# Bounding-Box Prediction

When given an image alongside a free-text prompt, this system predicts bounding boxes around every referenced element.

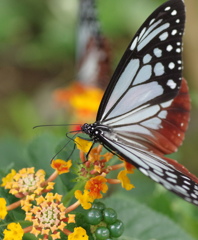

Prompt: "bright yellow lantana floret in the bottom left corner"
[3,223,24,240]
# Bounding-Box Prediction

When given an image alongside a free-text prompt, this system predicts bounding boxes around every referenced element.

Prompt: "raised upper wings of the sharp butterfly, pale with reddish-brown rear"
[97,0,190,154]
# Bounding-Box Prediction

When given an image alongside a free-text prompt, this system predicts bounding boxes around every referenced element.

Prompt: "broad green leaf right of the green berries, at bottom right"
[105,195,193,240]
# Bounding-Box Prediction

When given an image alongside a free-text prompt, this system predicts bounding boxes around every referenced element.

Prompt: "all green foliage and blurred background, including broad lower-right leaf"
[0,0,198,240]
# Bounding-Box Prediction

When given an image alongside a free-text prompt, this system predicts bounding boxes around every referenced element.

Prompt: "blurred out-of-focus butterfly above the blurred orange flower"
[76,0,111,89]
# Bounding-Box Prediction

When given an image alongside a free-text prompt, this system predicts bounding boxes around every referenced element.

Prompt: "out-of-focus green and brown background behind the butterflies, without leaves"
[0,0,198,236]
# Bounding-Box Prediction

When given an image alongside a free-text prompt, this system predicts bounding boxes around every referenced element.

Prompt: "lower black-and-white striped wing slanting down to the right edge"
[98,135,198,205]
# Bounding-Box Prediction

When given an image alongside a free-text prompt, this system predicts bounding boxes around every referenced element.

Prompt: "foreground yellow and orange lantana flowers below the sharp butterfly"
[0,137,134,240]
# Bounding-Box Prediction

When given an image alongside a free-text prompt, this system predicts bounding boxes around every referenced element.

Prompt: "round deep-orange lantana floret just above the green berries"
[85,176,108,199]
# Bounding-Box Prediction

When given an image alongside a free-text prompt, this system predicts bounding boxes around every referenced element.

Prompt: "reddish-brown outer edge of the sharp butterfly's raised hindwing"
[150,78,191,155]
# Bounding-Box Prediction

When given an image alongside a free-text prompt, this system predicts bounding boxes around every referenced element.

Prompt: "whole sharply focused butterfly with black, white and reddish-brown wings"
[81,0,198,205]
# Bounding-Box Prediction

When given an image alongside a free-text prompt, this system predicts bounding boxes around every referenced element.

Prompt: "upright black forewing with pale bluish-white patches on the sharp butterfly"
[97,0,185,121]
